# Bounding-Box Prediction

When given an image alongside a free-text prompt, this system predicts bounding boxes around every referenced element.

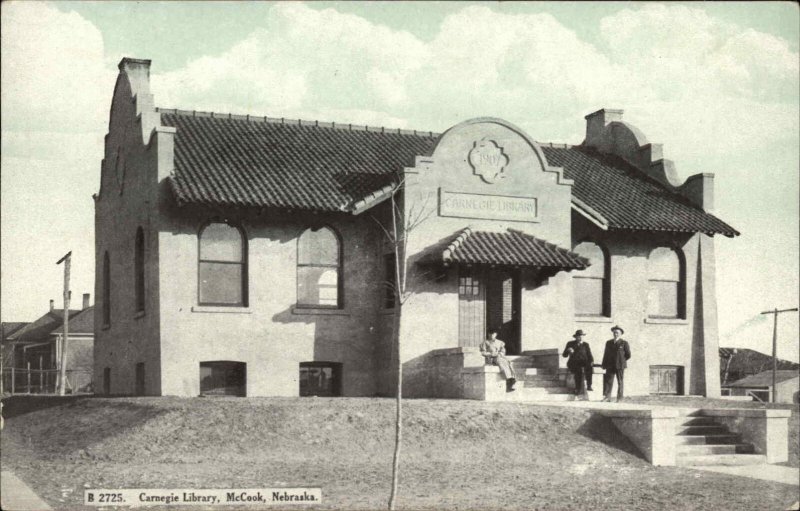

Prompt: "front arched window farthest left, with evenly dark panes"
[198,222,247,307]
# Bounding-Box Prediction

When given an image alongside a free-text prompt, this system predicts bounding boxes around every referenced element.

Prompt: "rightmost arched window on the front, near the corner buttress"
[647,247,686,318]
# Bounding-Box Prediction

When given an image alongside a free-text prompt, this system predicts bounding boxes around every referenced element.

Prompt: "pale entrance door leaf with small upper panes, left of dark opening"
[458,268,486,346]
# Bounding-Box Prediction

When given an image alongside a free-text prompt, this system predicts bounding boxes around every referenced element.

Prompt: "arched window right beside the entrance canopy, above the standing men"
[572,241,611,317]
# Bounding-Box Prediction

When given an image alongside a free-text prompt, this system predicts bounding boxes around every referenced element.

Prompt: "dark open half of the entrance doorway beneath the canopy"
[486,268,521,355]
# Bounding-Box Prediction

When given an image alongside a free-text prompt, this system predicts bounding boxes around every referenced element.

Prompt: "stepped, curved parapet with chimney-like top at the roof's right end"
[582,108,714,211]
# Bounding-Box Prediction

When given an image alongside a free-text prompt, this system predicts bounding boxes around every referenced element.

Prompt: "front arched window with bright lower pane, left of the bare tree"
[297,227,342,307]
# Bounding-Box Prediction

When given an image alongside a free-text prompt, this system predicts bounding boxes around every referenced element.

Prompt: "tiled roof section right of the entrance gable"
[542,146,739,236]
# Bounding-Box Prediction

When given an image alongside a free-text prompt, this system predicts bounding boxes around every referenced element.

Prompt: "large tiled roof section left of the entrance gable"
[160,110,436,212]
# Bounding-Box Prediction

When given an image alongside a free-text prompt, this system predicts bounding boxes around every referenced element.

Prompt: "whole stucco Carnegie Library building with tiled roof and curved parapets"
[94,58,739,397]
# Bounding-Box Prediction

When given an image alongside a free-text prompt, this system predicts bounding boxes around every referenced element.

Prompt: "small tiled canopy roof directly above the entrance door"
[442,228,589,270]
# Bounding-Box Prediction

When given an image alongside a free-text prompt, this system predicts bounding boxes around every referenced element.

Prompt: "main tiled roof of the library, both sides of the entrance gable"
[159,109,739,236]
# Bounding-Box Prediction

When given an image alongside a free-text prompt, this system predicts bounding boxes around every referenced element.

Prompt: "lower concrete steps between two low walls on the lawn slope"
[675,411,767,466]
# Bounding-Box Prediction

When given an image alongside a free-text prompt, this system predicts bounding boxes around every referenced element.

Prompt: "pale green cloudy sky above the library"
[0,1,800,360]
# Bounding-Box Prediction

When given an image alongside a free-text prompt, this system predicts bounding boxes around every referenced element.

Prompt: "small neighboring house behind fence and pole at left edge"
[4,293,94,392]
